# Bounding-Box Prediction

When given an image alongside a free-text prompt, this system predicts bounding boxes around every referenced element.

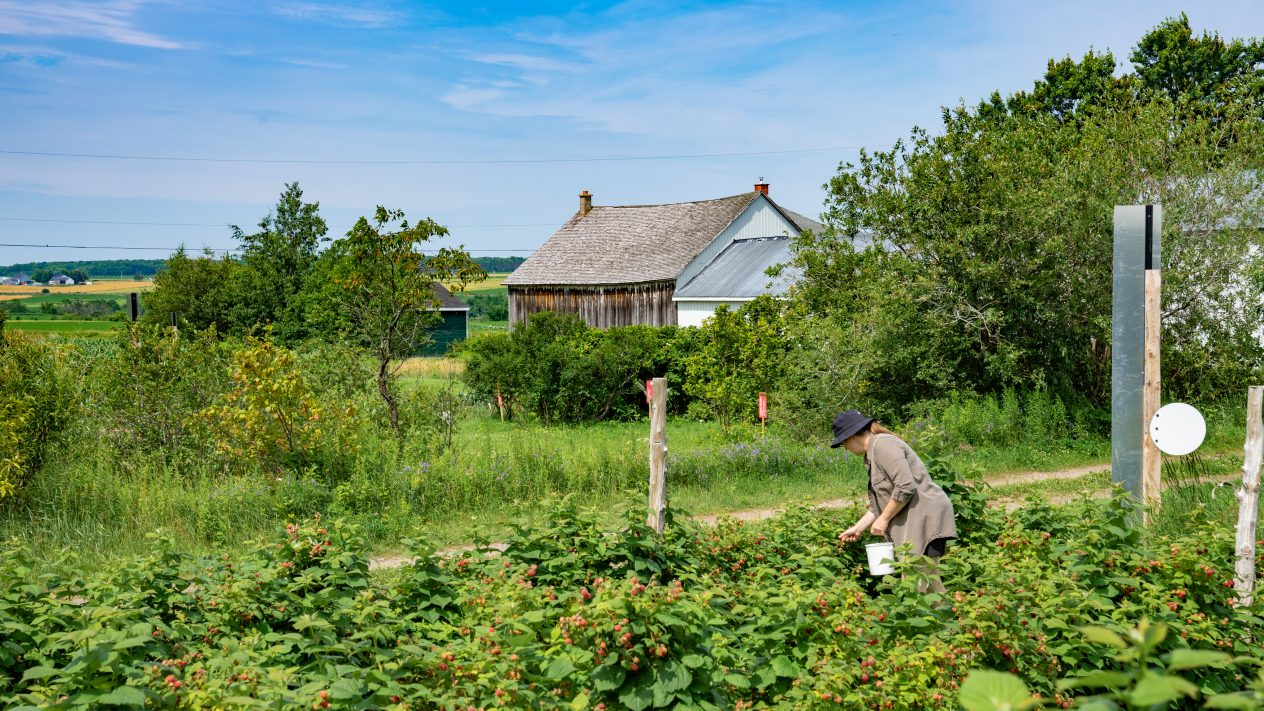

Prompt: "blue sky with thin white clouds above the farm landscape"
[0,0,1264,264]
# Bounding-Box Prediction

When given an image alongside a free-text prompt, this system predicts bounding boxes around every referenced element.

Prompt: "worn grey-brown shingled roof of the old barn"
[504,192,758,286]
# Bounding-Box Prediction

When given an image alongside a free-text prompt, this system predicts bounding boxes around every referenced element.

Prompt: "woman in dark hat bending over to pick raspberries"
[830,410,957,592]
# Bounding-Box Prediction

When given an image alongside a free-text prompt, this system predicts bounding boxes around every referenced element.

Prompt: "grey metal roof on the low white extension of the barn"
[674,237,801,301]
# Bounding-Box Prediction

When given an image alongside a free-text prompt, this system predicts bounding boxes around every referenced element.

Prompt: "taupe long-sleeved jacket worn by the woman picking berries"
[865,434,957,555]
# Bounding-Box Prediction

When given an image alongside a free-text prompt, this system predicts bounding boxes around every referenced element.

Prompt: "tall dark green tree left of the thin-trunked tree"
[233,182,329,343]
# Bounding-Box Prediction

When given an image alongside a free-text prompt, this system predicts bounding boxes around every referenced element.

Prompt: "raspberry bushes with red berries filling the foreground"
[0,485,1261,710]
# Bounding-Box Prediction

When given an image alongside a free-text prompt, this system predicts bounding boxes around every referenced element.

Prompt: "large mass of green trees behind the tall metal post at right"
[782,16,1264,429]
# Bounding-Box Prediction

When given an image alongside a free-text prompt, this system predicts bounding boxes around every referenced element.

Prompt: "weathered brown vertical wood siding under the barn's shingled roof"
[509,281,676,329]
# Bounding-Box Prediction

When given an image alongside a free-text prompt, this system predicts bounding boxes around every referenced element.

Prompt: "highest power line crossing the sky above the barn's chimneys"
[0,145,866,166]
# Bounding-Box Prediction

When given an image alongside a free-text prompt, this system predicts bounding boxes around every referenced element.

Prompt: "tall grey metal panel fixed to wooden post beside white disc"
[1111,205,1163,498]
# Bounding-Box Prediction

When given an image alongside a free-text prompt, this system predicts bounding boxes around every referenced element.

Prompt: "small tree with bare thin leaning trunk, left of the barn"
[330,205,487,435]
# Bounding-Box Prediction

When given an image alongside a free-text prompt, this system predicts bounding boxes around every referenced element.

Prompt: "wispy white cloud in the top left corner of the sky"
[0,0,183,49]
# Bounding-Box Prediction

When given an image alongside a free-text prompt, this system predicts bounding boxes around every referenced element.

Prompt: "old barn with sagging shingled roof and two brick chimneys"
[504,182,822,328]
